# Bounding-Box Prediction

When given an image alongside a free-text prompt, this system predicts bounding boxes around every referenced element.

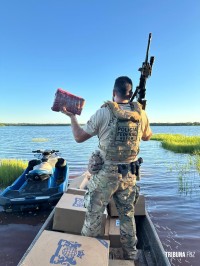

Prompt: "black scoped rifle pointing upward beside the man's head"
[130,33,154,110]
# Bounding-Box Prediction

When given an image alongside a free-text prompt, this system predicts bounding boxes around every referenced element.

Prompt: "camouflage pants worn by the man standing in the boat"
[82,165,139,259]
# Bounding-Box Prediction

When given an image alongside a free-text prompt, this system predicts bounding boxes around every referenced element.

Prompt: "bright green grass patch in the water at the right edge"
[151,134,200,154]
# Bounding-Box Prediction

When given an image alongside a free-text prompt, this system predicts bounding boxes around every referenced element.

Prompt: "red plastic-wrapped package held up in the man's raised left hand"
[51,88,85,115]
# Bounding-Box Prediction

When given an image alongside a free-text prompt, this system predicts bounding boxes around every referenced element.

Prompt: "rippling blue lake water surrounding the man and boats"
[0,126,200,266]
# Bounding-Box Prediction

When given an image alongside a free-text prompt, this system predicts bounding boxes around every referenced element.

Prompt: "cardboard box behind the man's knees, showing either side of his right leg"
[108,195,145,217]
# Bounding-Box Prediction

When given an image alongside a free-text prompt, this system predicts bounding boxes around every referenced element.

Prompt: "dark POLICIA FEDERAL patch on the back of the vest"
[115,121,138,142]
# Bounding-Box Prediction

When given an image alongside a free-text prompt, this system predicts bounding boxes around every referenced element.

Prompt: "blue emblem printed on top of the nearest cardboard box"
[50,239,85,265]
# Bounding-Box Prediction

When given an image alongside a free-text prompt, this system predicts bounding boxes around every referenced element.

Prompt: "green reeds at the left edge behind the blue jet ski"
[0,159,28,188]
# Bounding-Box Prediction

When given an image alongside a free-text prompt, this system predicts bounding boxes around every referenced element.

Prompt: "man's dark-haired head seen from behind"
[113,76,133,101]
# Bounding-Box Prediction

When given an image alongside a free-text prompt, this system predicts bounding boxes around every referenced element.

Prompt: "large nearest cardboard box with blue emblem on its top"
[21,230,109,266]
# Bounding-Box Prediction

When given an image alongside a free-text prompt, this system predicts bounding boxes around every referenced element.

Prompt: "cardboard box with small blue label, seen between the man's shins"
[109,218,122,248]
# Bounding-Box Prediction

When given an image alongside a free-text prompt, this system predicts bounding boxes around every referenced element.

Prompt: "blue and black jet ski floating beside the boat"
[0,150,69,212]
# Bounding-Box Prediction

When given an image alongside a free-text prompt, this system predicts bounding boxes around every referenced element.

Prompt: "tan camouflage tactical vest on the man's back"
[99,101,142,162]
